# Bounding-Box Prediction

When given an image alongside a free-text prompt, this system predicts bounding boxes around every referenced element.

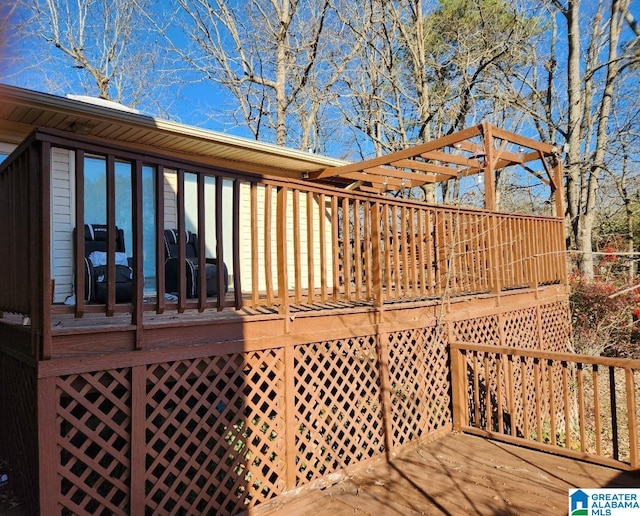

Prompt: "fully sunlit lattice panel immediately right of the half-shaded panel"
[295,336,384,485]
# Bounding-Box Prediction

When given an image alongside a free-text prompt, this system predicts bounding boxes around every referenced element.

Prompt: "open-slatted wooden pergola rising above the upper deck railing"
[303,122,563,215]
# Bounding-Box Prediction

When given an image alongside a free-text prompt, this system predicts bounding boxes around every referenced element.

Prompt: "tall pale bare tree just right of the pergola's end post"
[545,0,637,277]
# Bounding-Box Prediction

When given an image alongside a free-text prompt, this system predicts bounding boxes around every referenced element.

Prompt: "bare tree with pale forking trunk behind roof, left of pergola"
[173,0,360,149]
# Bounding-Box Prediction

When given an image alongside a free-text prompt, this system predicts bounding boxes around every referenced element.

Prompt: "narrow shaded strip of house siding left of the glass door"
[51,148,75,303]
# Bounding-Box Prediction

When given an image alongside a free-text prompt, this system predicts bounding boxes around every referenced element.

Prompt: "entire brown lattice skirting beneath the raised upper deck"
[15,296,566,515]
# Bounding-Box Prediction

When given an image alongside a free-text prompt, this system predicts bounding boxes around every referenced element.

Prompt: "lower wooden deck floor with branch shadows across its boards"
[252,433,640,516]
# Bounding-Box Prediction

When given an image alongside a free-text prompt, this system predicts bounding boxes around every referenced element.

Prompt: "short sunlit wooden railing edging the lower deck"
[450,342,640,469]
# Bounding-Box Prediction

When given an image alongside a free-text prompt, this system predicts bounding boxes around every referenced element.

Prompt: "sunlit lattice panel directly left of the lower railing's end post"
[389,327,451,448]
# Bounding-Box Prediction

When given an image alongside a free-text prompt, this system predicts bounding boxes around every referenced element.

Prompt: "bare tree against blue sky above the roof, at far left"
[8,0,169,113]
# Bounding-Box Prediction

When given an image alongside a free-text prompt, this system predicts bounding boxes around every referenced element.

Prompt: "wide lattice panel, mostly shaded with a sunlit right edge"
[146,350,285,514]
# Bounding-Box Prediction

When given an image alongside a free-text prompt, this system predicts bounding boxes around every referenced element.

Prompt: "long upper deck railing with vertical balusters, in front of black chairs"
[0,131,566,330]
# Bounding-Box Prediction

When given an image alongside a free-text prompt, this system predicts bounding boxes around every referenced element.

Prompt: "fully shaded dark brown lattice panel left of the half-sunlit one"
[56,369,131,514]
